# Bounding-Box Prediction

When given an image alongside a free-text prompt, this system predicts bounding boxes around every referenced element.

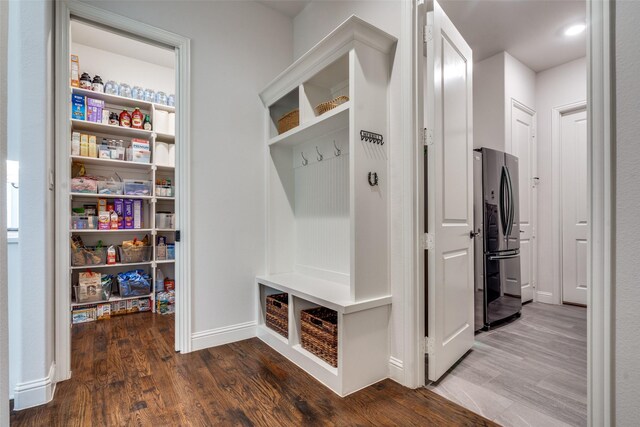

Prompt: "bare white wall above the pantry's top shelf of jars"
[71,42,176,95]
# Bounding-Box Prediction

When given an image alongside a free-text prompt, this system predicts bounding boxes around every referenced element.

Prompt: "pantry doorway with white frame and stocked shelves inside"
[55,2,191,382]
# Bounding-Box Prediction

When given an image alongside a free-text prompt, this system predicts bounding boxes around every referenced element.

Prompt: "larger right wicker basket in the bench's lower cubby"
[300,307,338,368]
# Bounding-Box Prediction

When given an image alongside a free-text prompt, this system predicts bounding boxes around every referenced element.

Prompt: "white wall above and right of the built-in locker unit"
[293,0,411,382]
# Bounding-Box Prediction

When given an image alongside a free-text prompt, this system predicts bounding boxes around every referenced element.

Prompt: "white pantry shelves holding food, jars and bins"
[59,87,176,320]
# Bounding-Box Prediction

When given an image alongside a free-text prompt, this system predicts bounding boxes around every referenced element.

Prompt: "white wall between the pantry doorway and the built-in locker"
[81,1,293,348]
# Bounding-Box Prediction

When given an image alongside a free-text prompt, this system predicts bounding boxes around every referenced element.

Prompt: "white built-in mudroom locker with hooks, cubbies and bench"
[256,16,397,396]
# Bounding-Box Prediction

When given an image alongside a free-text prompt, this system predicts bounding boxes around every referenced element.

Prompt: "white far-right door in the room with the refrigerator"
[560,110,589,305]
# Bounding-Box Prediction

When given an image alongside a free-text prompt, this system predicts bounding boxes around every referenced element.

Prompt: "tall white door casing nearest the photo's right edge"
[587,0,615,427]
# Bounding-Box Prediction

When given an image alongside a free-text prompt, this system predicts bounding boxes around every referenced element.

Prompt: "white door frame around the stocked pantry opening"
[54,1,192,382]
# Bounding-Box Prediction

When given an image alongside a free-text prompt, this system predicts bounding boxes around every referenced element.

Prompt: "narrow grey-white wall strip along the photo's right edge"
[613,1,640,426]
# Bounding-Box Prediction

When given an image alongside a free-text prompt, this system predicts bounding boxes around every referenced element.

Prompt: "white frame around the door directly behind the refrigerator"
[509,98,538,302]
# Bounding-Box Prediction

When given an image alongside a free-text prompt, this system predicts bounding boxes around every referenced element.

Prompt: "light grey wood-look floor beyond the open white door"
[427,303,587,427]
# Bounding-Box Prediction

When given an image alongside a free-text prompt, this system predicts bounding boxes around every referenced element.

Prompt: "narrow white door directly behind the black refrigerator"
[511,101,536,302]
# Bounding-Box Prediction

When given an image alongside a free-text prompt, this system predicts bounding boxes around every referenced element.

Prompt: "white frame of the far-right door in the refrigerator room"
[544,100,587,304]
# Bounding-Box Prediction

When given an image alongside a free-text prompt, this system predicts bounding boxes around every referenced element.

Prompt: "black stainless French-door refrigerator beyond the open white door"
[473,148,522,331]
